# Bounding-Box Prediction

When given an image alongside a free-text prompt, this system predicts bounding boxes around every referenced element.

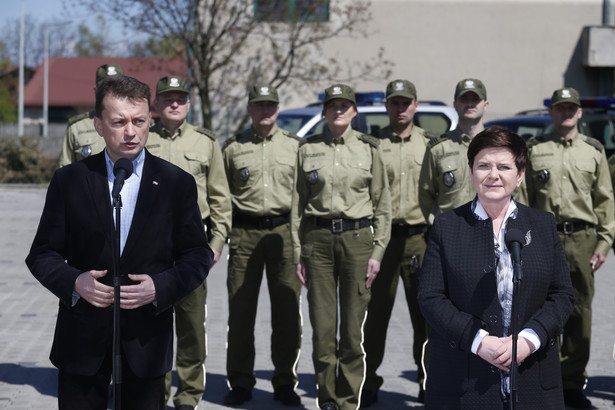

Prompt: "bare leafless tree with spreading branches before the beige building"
[65,0,391,133]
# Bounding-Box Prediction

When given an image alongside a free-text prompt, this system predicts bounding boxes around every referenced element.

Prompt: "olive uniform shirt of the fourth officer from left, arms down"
[291,129,391,264]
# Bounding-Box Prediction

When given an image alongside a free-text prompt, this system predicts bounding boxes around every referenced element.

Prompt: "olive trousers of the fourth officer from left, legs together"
[301,226,373,410]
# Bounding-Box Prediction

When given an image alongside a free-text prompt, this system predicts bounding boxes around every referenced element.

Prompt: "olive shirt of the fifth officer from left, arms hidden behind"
[376,125,435,225]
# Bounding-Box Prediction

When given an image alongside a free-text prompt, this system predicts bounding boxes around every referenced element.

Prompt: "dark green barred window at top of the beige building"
[254,0,329,22]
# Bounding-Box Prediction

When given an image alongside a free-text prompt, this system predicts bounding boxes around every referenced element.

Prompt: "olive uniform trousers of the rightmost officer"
[560,228,598,390]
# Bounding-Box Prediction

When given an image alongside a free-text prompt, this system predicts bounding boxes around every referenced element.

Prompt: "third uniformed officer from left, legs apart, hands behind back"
[223,84,301,406]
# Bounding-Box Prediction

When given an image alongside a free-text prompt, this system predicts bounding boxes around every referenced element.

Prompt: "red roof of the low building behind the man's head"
[24,57,187,107]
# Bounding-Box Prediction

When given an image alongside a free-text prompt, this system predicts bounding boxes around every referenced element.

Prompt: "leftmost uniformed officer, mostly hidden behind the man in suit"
[58,64,124,168]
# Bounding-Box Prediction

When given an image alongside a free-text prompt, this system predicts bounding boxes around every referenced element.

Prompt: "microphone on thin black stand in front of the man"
[112,194,122,410]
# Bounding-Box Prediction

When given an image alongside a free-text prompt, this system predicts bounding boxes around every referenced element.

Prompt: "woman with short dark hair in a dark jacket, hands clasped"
[419,127,574,409]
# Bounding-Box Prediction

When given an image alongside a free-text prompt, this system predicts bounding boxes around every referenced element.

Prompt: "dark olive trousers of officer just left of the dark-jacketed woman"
[364,234,428,393]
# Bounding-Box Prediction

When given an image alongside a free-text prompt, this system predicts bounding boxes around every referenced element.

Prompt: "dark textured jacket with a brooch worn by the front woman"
[419,199,574,409]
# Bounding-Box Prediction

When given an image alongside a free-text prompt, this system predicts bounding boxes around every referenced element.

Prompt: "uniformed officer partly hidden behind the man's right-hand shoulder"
[146,76,231,410]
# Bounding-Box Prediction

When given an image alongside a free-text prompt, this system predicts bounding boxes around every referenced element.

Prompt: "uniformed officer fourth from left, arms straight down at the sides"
[291,84,391,410]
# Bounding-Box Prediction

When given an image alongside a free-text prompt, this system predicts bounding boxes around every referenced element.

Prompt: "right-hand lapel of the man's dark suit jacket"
[120,151,160,259]
